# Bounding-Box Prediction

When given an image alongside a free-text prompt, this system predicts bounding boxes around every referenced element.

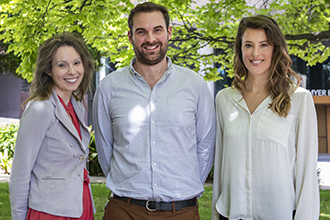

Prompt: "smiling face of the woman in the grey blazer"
[47,46,84,101]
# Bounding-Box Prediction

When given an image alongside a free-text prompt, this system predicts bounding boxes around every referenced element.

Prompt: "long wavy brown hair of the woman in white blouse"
[232,15,300,117]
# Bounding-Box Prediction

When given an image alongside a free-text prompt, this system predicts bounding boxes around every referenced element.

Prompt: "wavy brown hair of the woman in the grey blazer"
[23,32,94,106]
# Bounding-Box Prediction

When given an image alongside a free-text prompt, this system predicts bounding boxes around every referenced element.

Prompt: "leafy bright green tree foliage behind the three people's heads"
[0,0,330,81]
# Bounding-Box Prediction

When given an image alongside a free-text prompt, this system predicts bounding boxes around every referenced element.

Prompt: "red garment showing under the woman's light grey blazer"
[26,96,94,220]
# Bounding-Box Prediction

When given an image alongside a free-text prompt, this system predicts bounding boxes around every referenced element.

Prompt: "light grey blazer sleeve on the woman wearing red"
[9,101,54,220]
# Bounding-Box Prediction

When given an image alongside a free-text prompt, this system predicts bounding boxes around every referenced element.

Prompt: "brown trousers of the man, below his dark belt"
[104,198,200,220]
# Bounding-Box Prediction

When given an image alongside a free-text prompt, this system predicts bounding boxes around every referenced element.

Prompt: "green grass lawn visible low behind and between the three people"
[0,183,330,220]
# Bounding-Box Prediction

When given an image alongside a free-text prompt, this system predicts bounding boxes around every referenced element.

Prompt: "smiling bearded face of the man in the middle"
[128,11,172,65]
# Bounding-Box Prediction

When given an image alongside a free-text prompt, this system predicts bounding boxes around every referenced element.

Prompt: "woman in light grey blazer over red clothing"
[9,33,94,220]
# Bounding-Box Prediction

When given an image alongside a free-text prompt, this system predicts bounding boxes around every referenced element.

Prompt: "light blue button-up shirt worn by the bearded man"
[93,57,215,201]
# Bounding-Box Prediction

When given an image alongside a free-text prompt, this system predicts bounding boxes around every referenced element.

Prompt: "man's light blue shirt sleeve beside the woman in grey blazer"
[93,84,113,176]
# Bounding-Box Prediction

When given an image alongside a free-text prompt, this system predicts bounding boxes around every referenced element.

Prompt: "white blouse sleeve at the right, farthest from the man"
[295,92,320,220]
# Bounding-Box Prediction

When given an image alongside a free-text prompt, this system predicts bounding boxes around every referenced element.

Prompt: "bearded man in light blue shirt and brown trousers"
[93,2,215,220]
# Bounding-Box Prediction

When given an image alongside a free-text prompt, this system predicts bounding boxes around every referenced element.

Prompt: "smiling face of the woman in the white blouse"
[241,28,274,79]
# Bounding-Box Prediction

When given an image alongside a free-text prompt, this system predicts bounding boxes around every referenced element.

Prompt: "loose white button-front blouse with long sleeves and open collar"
[212,87,320,220]
